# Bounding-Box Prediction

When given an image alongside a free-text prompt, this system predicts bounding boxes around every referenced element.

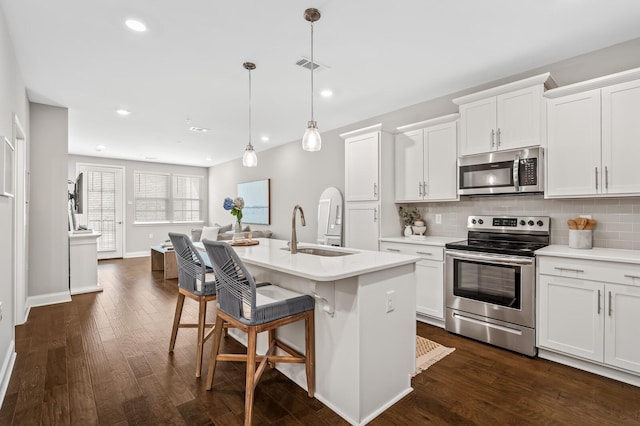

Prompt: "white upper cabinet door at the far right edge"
[602,80,640,194]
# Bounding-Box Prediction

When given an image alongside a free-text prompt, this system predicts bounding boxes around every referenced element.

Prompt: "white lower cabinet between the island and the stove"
[380,241,444,326]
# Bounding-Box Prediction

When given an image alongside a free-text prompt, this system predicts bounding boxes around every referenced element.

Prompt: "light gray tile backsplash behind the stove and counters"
[409,195,640,250]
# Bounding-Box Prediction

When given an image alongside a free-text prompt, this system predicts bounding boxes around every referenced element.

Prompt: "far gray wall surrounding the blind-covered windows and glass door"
[67,155,208,257]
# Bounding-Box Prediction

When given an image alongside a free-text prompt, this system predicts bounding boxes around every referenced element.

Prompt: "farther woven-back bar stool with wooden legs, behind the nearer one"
[169,232,216,377]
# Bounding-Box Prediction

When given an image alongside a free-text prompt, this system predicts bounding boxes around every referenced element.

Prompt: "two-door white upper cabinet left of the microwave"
[395,114,459,202]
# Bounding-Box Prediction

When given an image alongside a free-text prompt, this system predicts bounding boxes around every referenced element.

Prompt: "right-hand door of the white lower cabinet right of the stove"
[604,284,640,373]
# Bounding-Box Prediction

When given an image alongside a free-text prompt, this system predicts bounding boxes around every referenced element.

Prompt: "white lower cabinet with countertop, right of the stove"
[538,256,640,374]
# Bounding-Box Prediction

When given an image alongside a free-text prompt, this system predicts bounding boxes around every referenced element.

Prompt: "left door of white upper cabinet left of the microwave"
[395,129,424,202]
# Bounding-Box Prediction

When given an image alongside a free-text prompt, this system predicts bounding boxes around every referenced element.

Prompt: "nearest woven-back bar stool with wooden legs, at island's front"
[204,241,315,426]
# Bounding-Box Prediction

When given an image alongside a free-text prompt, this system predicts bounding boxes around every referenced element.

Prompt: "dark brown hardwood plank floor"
[0,258,640,425]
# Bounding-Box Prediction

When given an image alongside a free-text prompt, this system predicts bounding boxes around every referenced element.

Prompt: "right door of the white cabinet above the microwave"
[496,85,542,150]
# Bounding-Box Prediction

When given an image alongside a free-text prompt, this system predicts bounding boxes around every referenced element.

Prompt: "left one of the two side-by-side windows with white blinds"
[134,172,170,223]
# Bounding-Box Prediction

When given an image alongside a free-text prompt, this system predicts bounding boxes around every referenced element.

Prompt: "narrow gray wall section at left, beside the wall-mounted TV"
[29,103,69,297]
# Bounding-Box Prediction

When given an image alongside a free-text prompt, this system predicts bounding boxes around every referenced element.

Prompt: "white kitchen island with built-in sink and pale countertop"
[201,239,420,425]
